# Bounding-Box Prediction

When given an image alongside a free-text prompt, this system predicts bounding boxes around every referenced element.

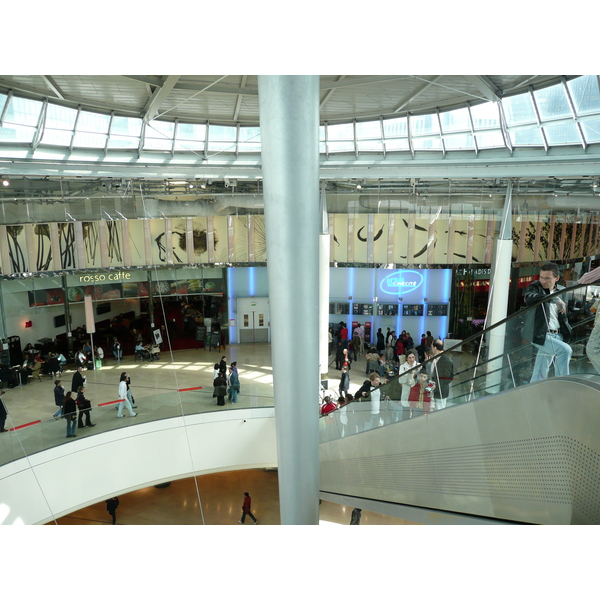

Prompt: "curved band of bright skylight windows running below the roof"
[0,75,600,154]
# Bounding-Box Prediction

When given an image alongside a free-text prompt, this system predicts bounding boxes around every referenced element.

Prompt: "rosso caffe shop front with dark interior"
[0,267,228,364]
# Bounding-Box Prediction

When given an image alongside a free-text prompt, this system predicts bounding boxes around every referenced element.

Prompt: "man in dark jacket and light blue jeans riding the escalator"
[525,262,573,383]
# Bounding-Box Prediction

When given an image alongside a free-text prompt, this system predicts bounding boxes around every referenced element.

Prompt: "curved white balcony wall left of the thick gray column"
[0,407,277,525]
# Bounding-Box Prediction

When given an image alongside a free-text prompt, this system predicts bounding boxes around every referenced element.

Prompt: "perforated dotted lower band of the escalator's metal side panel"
[321,436,600,523]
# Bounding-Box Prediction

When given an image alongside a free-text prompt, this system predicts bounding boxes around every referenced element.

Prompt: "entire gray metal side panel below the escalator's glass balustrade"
[320,376,600,524]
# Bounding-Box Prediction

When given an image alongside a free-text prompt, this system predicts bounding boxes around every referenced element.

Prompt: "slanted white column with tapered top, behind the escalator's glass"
[485,180,513,393]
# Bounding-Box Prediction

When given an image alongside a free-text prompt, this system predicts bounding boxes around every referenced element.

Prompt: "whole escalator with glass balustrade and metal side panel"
[320,278,600,524]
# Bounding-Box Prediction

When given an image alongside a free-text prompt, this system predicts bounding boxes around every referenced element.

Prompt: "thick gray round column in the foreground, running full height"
[258,75,321,525]
